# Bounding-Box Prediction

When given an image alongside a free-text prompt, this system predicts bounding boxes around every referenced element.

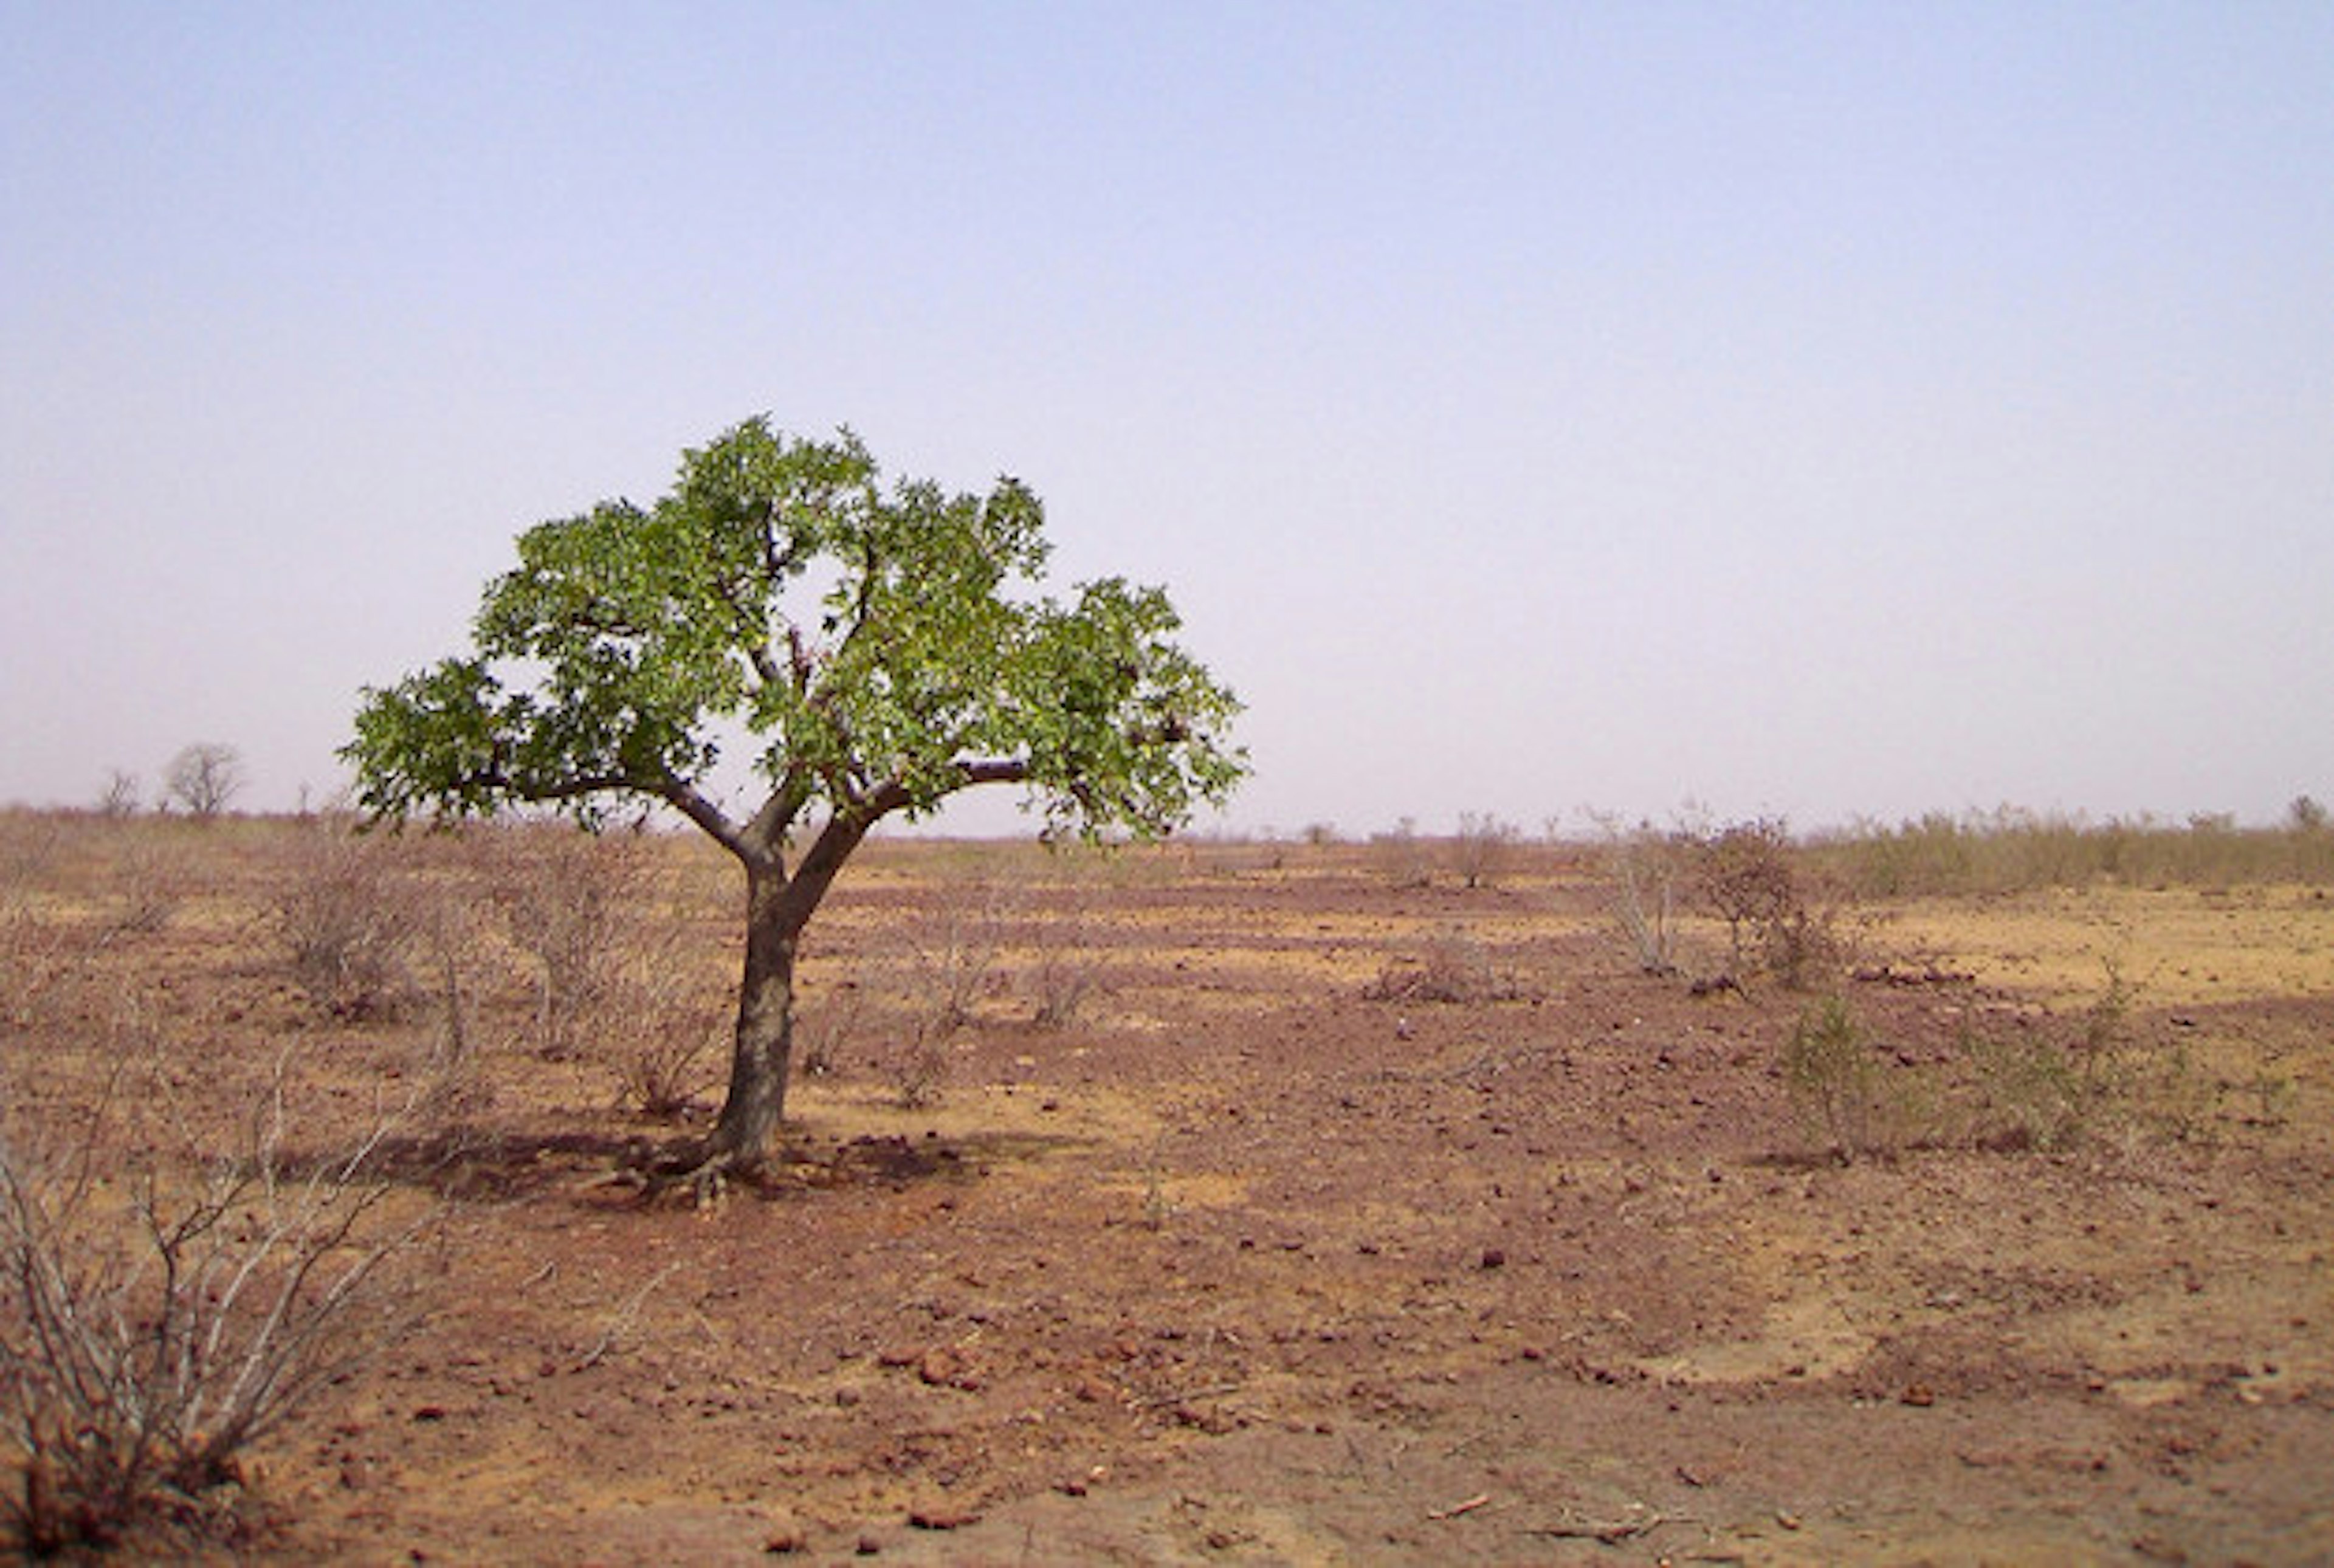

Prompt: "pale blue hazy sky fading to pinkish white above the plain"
[0,0,2334,833]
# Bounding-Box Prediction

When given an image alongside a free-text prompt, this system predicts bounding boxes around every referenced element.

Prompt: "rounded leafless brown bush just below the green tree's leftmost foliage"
[266,819,416,1022]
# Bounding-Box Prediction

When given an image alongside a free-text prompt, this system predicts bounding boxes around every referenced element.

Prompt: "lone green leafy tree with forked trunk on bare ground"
[341,418,1247,1178]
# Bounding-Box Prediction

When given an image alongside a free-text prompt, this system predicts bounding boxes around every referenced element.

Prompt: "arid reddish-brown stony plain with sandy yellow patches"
[0,812,2334,1563]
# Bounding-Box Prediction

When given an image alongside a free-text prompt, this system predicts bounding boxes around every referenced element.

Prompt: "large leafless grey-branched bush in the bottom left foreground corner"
[0,1073,434,1554]
